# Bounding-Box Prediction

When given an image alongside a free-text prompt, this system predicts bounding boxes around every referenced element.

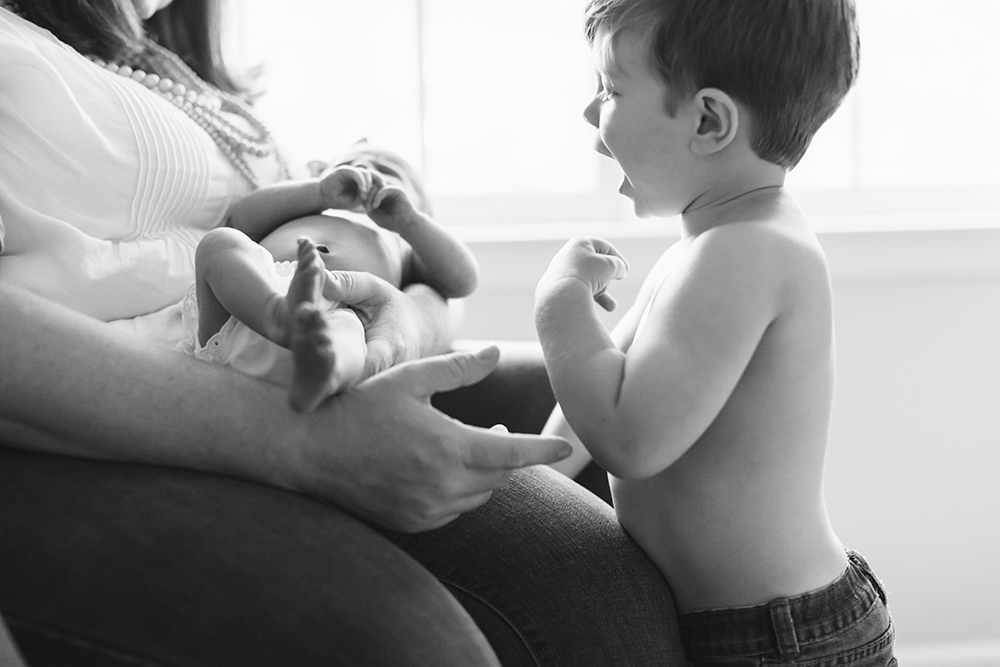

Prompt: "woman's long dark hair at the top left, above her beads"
[19,0,244,93]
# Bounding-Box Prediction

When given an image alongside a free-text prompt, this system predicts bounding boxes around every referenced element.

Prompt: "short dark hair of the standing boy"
[585,0,860,169]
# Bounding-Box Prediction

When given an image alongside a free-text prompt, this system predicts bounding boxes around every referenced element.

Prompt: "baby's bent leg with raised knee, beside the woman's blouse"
[195,227,291,347]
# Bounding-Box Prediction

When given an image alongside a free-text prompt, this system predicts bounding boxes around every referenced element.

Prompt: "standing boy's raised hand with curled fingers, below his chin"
[539,236,628,312]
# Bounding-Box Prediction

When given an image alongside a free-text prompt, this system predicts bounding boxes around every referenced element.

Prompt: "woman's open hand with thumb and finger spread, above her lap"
[292,346,571,532]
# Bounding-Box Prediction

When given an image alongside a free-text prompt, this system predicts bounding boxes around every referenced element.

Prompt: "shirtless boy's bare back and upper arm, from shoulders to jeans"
[612,189,845,611]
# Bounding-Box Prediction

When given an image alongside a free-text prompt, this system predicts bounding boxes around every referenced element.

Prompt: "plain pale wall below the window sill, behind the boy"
[461,218,1000,666]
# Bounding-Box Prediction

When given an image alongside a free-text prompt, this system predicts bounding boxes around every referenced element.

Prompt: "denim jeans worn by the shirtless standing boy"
[678,551,896,667]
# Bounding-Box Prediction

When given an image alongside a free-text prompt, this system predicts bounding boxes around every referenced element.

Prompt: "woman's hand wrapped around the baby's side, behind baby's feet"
[323,271,451,380]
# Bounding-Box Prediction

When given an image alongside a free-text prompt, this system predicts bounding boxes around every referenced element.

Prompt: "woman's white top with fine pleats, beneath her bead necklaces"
[0,8,276,343]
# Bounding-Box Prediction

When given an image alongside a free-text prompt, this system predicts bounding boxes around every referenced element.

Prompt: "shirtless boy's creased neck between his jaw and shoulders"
[681,165,787,237]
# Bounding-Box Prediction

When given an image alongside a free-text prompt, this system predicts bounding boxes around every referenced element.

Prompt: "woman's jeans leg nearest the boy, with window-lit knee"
[386,466,684,667]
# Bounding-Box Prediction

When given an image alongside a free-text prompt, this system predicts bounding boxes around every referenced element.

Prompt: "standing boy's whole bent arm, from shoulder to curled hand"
[535,229,779,479]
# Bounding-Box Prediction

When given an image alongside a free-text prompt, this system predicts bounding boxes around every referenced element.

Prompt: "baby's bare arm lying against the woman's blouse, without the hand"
[226,178,330,242]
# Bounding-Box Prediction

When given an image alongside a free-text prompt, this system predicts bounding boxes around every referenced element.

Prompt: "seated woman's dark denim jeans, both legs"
[0,446,684,667]
